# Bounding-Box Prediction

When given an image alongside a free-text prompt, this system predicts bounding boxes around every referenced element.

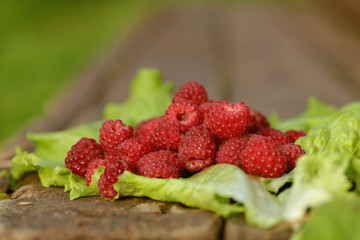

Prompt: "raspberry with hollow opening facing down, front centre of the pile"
[178,125,216,172]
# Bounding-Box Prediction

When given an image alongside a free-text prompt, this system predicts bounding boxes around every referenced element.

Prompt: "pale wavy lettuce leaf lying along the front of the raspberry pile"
[114,164,281,228]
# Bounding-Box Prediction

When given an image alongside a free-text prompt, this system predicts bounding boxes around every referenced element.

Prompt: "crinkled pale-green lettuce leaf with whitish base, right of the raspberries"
[281,104,360,220]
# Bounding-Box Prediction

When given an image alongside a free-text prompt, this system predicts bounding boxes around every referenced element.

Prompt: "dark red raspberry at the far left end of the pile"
[65,137,104,178]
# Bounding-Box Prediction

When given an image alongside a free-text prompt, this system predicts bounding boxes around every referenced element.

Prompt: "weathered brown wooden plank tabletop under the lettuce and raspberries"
[0,5,360,239]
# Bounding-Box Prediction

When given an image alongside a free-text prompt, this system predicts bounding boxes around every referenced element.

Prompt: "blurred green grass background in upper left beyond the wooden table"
[0,0,306,142]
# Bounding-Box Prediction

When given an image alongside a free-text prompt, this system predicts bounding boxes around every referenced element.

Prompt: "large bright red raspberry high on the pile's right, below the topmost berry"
[205,101,250,138]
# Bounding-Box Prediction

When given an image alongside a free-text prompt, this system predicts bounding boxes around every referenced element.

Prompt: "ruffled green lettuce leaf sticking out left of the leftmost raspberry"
[10,122,101,182]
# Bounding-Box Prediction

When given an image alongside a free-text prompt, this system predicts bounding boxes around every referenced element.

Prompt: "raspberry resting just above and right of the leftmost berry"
[100,120,134,152]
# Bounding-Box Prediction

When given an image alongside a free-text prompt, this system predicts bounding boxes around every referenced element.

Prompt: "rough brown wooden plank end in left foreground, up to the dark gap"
[0,175,222,240]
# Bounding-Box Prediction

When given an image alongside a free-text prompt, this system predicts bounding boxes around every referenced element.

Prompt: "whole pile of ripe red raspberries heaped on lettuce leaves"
[65,82,306,199]
